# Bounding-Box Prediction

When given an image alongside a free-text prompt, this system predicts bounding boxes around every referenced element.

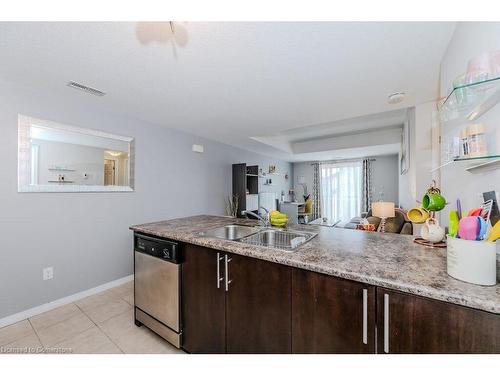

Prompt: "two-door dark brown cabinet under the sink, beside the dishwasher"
[182,245,291,353]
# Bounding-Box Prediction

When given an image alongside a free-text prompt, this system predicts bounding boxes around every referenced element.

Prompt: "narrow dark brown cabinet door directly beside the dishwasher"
[182,245,226,353]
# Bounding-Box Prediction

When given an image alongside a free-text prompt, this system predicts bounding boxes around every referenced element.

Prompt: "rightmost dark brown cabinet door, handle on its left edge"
[377,288,500,353]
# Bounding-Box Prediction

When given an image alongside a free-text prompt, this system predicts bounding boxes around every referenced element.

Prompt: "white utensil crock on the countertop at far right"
[446,236,497,286]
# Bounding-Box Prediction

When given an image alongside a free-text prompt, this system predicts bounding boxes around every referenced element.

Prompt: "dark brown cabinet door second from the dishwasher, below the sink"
[226,254,291,353]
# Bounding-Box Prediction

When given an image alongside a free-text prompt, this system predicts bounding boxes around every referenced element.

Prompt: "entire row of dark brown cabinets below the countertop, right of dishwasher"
[182,245,500,353]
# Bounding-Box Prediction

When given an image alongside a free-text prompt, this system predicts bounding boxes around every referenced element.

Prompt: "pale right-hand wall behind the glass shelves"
[440,22,500,217]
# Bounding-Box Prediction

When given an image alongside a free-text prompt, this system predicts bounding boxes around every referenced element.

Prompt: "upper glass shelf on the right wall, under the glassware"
[439,77,500,122]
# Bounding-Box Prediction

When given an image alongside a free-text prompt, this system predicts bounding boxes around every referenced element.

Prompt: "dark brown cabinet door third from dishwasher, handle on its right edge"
[292,269,375,353]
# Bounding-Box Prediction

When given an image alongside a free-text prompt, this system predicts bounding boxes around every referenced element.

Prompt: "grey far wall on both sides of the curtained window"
[293,155,399,204]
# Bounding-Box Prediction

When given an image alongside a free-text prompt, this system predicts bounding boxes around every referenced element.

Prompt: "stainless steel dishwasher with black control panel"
[134,233,182,348]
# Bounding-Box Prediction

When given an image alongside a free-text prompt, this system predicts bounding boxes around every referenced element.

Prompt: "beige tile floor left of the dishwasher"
[0,282,183,354]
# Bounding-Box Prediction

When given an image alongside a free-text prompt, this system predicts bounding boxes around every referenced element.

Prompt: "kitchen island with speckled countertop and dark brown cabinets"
[131,215,500,353]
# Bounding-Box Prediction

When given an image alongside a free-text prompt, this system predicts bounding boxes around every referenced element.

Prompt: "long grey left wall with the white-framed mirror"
[0,82,291,318]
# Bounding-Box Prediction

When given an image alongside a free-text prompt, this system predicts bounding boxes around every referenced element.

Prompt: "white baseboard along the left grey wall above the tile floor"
[0,275,134,328]
